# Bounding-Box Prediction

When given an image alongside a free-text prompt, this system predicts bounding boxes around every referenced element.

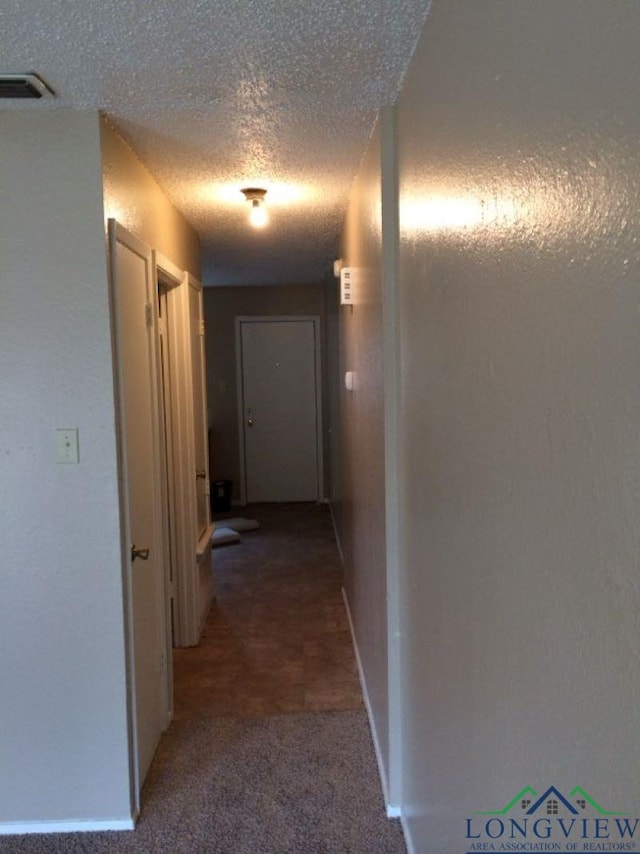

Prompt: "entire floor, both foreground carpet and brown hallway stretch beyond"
[0,504,405,854]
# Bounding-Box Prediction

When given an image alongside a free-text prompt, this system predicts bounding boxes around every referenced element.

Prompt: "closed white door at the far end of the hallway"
[238,318,321,502]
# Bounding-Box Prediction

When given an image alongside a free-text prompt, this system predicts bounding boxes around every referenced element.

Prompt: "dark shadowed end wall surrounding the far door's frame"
[204,285,327,498]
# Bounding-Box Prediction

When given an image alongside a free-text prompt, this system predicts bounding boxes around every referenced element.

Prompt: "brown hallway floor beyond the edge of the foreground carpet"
[174,504,364,720]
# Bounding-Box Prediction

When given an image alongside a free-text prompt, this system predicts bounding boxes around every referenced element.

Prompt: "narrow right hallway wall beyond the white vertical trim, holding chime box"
[334,118,389,796]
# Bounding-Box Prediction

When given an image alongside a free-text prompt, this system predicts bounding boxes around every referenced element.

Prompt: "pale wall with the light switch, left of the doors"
[0,111,130,823]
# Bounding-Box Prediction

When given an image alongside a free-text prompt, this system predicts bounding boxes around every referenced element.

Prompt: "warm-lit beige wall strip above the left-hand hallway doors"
[100,118,200,279]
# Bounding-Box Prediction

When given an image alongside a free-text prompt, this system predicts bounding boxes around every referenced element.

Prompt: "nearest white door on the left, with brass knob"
[109,221,167,795]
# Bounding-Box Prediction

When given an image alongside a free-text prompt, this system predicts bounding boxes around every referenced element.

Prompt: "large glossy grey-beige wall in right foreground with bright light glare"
[399,0,640,854]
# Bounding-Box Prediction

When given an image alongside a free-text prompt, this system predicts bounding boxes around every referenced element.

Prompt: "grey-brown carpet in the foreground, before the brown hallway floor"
[0,711,405,854]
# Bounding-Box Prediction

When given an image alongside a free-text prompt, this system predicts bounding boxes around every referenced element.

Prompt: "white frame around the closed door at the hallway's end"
[236,314,325,506]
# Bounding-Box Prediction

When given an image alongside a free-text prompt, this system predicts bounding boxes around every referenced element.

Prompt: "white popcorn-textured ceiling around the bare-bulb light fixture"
[0,0,429,284]
